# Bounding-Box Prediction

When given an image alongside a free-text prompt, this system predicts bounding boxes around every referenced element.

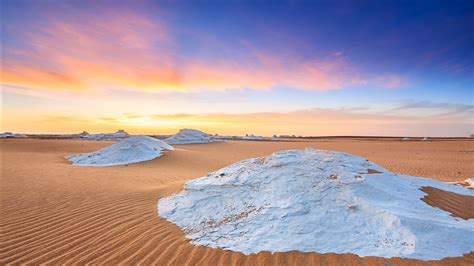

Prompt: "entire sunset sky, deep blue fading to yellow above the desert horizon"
[0,0,474,136]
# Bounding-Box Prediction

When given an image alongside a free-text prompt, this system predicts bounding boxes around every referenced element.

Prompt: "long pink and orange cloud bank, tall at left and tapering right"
[1,4,401,92]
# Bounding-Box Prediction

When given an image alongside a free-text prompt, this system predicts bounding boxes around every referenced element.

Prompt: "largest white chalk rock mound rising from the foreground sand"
[158,149,474,259]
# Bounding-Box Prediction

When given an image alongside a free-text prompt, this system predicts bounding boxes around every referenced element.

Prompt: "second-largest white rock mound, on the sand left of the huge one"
[66,136,174,166]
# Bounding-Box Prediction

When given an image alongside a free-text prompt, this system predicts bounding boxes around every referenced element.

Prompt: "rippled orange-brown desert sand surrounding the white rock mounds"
[0,139,474,265]
